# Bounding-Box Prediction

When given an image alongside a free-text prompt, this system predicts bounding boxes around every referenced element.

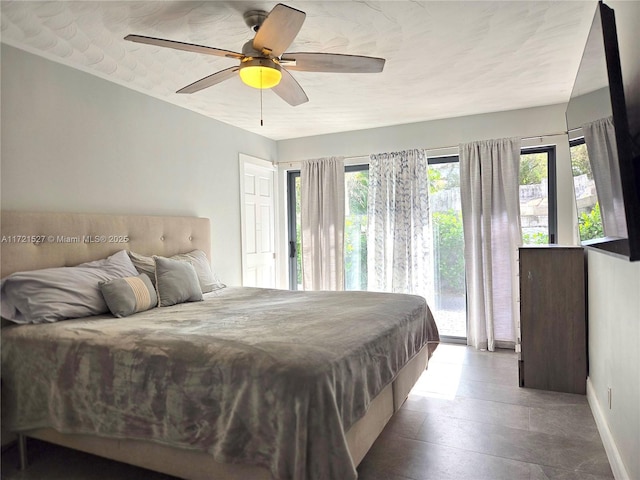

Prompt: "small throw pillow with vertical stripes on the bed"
[100,273,158,317]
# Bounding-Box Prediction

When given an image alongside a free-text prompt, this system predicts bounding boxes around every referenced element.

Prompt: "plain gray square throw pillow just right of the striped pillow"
[153,255,202,307]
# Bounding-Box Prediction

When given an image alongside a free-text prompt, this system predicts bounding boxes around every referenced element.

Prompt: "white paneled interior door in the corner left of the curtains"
[240,154,276,288]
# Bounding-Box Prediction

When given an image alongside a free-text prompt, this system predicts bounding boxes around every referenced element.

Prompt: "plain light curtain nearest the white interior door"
[300,157,345,290]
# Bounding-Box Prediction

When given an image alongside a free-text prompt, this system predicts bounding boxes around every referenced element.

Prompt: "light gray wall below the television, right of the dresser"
[587,251,640,480]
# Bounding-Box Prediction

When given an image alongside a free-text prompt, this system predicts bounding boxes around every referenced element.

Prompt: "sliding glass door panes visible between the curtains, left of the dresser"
[288,157,467,338]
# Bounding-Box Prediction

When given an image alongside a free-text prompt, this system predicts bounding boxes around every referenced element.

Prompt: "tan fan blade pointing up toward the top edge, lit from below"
[253,3,307,57]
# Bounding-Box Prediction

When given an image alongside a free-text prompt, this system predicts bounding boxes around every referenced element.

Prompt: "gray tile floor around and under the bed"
[2,344,613,480]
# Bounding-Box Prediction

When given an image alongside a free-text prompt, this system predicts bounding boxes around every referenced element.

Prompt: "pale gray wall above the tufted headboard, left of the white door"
[1,44,276,285]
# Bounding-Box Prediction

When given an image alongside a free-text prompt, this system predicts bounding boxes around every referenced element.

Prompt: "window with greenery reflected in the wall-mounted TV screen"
[569,138,604,242]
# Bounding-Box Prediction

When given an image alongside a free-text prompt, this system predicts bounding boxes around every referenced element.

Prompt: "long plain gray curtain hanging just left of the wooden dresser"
[460,138,522,351]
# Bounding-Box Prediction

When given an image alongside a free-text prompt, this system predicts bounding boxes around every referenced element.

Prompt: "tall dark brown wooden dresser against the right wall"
[518,245,587,394]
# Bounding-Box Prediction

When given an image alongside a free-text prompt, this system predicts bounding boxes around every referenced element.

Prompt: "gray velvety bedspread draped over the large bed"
[2,287,438,480]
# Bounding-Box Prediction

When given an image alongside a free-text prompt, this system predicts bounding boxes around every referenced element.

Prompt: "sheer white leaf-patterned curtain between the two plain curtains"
[367,150,433,299]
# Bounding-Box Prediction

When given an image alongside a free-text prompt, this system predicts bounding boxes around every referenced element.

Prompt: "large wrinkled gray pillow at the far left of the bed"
[0,250,138,323]
